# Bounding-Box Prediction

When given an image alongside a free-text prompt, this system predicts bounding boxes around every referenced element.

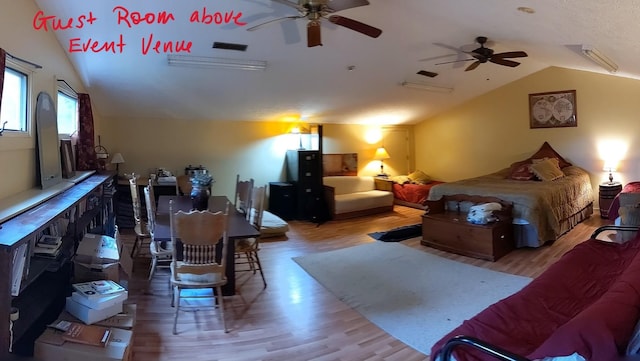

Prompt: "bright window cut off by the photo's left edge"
[0,64,29,132]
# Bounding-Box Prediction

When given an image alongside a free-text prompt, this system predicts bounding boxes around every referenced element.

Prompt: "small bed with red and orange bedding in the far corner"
[389,170,443,209]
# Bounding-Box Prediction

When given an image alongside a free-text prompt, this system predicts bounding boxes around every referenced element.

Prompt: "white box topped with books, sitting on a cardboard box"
[66,280,129,325]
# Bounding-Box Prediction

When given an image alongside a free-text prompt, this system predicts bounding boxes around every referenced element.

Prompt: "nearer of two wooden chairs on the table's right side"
[235,186,267,288]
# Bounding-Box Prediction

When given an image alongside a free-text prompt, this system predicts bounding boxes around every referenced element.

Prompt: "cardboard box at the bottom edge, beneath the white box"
[33,327,133,361]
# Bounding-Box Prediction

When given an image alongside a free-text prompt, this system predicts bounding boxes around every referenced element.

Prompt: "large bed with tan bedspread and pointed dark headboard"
[429,142,594,247]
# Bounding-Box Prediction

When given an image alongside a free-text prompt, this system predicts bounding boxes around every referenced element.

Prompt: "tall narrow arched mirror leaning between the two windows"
[36,92,62,189]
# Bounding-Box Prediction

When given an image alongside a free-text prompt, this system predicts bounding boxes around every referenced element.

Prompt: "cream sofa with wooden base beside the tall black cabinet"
[322,176,393,219]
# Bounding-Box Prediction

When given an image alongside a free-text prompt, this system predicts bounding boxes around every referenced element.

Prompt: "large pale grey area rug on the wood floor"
[293,242,531,355]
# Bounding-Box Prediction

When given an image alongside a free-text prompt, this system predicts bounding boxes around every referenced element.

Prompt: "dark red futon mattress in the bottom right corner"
[431,237,640,361]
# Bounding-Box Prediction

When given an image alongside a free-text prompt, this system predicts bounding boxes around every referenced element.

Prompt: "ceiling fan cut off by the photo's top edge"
[247,0,382,47]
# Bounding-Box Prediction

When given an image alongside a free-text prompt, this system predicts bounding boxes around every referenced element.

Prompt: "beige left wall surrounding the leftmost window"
[0,0,90,199]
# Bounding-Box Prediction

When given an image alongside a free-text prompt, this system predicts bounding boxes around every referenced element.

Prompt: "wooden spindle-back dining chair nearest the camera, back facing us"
[169,200,229,335]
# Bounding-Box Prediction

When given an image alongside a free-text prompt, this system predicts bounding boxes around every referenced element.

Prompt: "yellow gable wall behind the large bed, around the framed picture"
[415,67,640,194]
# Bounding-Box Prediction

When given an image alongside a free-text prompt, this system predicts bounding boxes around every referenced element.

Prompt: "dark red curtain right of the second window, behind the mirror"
[76,93,98,170]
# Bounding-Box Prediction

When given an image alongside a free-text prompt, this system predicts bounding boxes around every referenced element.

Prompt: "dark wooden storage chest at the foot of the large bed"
[421,194,515,261]
